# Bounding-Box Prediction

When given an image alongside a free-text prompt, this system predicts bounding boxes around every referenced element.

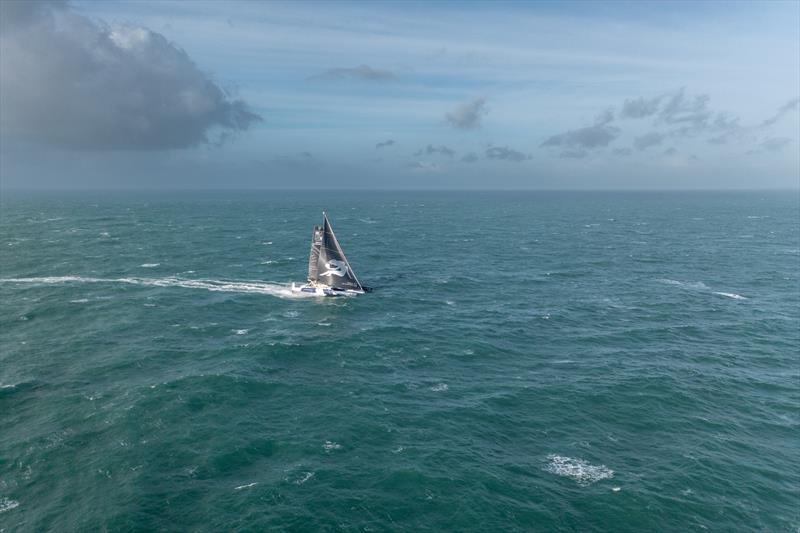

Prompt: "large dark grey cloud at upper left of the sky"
[0,1,262,150]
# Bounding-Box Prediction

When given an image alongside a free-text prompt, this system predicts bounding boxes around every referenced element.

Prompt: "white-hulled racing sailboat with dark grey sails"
[292,211,371,296]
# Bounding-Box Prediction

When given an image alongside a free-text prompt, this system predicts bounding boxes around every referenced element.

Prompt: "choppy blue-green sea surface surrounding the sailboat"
[0,191,800,532]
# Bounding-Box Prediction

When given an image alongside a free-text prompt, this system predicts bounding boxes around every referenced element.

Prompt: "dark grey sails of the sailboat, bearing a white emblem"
[308,212,363,290]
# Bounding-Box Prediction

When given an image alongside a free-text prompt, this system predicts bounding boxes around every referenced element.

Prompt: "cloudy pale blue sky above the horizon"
[0,0,800,190]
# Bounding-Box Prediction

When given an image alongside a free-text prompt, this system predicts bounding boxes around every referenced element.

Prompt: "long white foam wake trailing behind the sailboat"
[0,276,314,298]
